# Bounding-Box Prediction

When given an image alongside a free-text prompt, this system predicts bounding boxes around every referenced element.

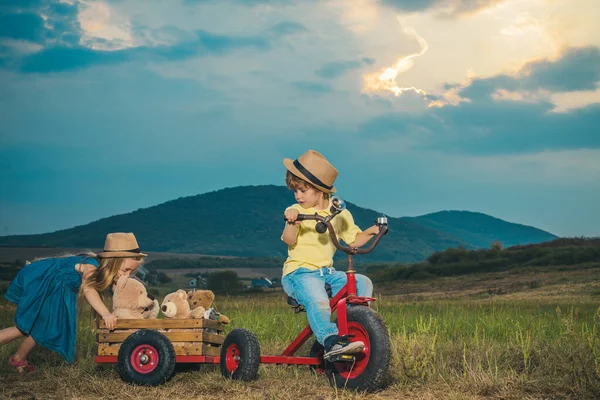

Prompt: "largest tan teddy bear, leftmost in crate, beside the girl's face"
[112,276,159,319]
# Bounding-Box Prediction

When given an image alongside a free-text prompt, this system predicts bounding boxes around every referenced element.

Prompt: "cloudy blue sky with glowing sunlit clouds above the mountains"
[0,0,600,236]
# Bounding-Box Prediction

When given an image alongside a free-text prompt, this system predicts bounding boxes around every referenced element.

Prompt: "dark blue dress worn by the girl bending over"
[4,256,99,363]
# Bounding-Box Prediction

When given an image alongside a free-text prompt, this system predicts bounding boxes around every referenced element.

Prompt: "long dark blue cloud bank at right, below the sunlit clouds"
[360,96,600,155]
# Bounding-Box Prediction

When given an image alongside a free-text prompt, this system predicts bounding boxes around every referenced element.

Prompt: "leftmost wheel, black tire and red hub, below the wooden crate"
[117,329,176,386]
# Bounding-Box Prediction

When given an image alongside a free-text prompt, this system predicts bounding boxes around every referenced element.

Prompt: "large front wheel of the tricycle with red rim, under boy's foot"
[326,306,392,392]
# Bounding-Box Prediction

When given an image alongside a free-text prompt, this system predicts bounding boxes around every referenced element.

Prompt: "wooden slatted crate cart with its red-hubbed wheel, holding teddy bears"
[95,319,225,385]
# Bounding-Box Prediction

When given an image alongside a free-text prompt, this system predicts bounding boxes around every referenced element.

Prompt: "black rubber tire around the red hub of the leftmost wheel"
[117,329,176,386]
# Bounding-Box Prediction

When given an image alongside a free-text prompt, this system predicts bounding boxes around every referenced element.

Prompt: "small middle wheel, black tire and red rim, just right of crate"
[219,328,260,381]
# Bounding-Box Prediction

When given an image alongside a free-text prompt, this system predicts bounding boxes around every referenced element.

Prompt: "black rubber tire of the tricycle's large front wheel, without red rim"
[326,306,392,392]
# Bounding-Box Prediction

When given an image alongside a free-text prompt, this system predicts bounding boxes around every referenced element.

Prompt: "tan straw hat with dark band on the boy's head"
[283,150,338,193]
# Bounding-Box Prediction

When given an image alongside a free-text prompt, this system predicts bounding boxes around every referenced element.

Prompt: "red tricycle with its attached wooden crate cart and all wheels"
[96,197,391,391]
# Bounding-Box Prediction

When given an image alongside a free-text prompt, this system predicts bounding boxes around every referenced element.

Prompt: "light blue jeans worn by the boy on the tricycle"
[281,268,373,344]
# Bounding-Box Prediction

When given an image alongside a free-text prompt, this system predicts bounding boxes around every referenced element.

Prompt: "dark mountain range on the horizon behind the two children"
[0,185,555,261]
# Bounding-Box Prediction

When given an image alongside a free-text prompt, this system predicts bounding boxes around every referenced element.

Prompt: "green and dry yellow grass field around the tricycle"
[0,267,600,399]
